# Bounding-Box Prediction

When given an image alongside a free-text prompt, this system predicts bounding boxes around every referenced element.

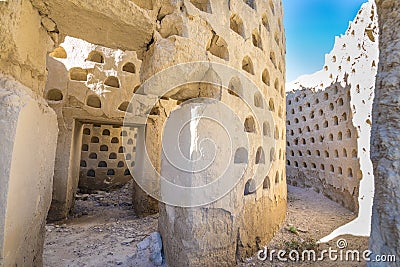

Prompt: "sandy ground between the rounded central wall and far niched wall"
[239,186,368,267]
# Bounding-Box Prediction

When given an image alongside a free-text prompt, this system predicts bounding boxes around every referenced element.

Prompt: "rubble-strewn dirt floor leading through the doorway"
[43,184,158,267]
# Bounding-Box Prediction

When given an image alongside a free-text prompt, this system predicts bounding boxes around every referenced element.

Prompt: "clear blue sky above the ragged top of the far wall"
[283,0,367,82]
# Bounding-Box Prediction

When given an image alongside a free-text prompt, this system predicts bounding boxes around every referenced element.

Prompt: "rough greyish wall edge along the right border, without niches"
[369,0,400,266]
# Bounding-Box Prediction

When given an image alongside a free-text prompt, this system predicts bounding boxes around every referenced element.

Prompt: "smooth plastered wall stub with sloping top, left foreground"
[0,75,57,266]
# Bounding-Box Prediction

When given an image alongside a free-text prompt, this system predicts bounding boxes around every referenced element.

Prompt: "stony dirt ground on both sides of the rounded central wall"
[43,184,368,267]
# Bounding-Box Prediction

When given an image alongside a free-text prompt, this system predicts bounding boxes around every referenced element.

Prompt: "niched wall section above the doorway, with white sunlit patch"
[44,37,145,121]
